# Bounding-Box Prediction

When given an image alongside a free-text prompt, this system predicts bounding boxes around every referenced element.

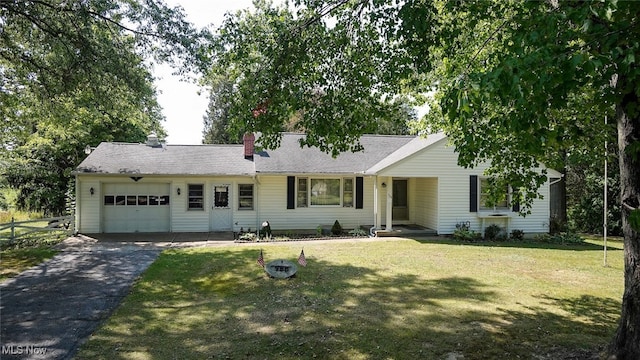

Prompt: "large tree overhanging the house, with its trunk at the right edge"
[212,0,640,359]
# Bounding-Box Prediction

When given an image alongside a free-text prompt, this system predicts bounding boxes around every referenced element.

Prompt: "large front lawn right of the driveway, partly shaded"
[77,239,623,360]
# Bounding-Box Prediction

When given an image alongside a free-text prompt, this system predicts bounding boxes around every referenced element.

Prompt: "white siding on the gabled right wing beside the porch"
[379,140,549,234]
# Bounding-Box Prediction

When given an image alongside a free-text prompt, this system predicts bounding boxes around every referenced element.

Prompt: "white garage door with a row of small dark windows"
[102,183,170,233]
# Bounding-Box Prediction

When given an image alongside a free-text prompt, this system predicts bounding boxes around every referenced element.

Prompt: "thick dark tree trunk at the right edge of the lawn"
[609,88,640,360]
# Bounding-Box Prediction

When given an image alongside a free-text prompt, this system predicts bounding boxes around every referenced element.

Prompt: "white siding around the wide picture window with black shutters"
[258,175,373,230]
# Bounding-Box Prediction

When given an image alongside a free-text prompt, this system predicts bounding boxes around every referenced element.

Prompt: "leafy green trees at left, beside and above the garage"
[0,0,207,214]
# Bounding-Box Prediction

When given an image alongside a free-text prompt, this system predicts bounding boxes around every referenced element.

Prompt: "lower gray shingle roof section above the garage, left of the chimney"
[76,143,255,175]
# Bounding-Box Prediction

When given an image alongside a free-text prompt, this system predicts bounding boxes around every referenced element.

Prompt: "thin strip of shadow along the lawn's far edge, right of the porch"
[411,236,623,251]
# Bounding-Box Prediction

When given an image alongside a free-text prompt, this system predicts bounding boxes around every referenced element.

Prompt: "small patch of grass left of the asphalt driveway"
[0,247,58,283]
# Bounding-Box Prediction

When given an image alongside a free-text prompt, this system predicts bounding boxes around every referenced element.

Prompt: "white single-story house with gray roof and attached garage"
[74,133,561,234]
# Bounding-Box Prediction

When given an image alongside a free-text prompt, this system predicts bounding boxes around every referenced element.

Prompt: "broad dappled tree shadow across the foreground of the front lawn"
[79,249,620,360]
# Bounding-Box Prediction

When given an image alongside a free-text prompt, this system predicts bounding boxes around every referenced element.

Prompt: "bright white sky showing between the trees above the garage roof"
[153,0,253,145]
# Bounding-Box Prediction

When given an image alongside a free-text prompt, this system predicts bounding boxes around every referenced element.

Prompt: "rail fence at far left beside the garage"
[0,215,74,243]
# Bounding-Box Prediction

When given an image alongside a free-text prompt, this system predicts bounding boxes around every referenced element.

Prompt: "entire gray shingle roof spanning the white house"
[76,134,443,175]
